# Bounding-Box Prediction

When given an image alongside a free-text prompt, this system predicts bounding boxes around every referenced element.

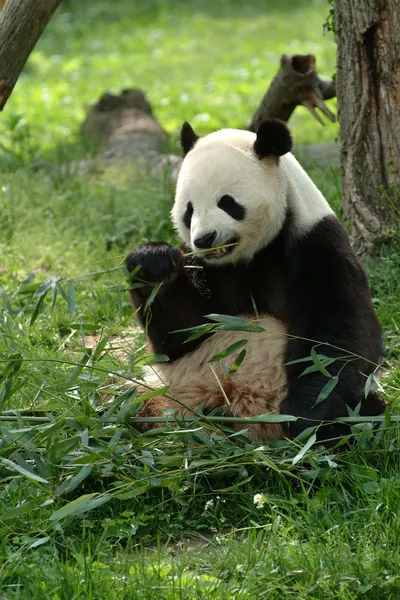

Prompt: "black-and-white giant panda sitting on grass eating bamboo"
[126,119,384,440]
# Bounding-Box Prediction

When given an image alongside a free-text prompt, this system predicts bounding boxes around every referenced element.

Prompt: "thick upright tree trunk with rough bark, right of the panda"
[335,0,400,255]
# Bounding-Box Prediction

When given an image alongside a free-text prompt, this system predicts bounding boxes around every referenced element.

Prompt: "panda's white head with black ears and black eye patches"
[172,119,292,265]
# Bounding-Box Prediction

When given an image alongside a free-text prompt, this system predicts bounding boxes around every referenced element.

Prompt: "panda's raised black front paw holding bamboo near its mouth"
[125,242,183,284]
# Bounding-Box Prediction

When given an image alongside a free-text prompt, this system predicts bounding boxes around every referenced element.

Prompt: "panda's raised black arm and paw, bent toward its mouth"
[125,242,210,360]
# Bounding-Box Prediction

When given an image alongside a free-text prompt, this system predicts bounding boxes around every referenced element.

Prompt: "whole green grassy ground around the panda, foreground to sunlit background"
[0,0,400,600]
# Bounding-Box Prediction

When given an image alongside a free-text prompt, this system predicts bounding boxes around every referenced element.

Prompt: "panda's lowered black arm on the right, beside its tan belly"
[281,216,382,438]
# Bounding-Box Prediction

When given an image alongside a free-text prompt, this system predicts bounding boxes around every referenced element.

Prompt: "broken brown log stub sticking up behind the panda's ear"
[249,54,336,131]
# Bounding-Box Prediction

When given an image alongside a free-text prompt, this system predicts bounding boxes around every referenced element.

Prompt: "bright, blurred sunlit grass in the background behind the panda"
[4,0,338,157]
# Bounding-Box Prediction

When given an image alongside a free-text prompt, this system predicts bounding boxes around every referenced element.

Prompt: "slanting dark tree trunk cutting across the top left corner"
[0,0,61,110]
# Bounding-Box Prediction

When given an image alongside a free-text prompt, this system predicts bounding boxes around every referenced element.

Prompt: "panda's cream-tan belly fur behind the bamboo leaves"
[136,315,287,440]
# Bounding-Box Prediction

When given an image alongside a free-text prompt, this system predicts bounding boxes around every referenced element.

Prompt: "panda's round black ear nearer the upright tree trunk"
[254,119,293,159]
